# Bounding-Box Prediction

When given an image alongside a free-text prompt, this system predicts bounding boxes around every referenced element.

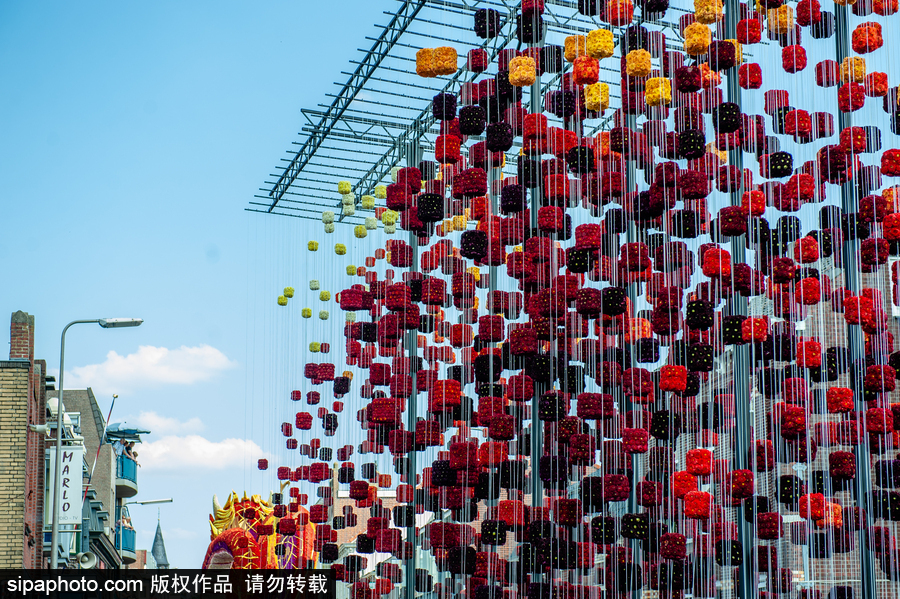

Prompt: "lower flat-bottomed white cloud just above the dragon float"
[136,435,269,472]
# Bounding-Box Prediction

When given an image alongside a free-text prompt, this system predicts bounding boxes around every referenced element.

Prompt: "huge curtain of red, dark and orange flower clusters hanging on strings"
[259,0,900,599]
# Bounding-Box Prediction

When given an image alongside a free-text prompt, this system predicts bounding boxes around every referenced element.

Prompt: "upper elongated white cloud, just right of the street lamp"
[66,345,237,394]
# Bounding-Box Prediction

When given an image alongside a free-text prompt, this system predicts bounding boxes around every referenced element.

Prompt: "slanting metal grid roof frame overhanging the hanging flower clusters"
[246,0,692,225]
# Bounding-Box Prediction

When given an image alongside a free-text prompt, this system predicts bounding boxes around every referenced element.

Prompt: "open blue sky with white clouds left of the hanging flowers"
[0,0,386,568]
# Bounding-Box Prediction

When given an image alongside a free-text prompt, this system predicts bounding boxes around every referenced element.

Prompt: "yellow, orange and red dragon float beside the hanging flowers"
[202,491,317,570]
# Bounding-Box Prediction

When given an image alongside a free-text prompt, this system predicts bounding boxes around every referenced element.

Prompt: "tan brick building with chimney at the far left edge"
[0,311,53,568]
